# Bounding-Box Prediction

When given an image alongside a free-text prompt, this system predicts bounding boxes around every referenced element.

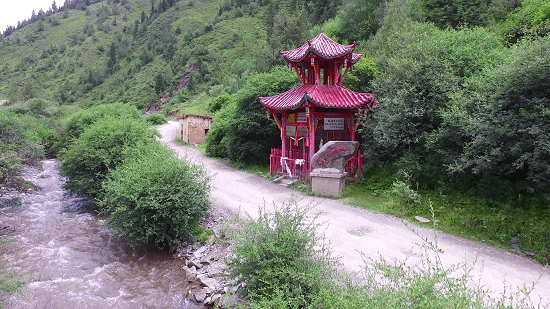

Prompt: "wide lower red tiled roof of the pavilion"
[258,85,378,110]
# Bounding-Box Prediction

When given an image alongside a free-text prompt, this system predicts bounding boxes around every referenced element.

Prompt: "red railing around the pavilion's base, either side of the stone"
[269,148,363,181]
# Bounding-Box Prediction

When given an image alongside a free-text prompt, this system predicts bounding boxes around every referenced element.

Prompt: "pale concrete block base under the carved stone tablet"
[309,168,346,196]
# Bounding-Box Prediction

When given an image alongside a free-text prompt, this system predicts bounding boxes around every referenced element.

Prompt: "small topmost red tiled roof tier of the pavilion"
[279,32,363,64]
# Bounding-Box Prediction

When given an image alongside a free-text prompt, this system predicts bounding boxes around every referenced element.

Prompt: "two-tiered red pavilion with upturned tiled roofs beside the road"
[258,32,378,180]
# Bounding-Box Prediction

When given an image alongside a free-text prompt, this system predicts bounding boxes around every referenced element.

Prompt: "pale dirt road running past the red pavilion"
[157,122,550,302]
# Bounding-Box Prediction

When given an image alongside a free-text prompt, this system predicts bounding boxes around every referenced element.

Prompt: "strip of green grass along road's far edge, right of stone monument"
[340,173,550,264]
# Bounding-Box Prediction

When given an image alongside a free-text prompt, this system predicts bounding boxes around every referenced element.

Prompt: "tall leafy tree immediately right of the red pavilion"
[361,22,503,185]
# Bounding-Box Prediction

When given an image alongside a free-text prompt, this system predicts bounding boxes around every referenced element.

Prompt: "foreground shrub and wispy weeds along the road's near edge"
[223,200,549,309]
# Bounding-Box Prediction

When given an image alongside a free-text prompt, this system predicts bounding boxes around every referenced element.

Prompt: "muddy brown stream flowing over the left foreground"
[0,160,201,309]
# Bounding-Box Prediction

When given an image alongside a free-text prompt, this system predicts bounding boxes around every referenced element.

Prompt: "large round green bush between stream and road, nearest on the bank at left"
[99,142,210,251]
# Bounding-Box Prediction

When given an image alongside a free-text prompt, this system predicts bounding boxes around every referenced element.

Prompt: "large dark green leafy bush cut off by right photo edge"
[446,39,550,187]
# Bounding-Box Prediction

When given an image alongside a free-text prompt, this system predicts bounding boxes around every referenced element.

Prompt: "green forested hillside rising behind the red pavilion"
[0,0,550,260]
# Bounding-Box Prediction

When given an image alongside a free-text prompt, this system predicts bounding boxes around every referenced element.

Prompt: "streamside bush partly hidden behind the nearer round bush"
[60,118,158,198]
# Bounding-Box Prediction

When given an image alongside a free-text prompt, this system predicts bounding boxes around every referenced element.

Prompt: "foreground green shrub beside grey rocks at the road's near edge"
[226,202,335,308]
